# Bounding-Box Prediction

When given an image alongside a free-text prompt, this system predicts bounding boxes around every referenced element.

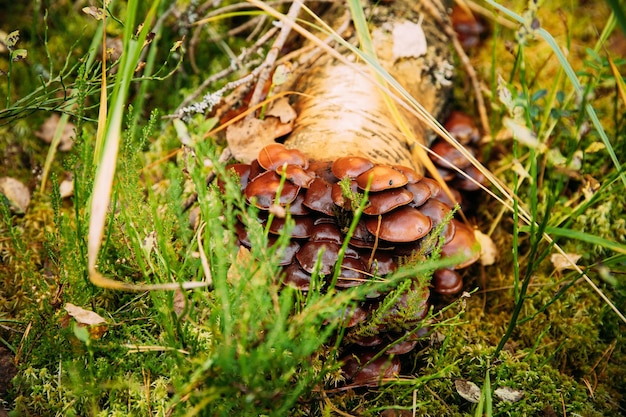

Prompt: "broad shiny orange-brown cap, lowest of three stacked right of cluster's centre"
[365,206,432,242]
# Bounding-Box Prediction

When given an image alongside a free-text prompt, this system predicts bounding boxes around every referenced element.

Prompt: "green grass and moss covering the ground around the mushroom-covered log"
[0,1,626,416]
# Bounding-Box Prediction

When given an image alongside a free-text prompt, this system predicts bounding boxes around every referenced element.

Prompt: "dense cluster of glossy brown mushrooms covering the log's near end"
[222,135,480,386]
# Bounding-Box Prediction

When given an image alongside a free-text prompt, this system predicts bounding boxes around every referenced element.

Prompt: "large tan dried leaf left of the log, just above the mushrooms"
[226,117,292,164]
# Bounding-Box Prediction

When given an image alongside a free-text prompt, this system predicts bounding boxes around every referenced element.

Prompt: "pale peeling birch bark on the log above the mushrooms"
[285,0,452,170]
